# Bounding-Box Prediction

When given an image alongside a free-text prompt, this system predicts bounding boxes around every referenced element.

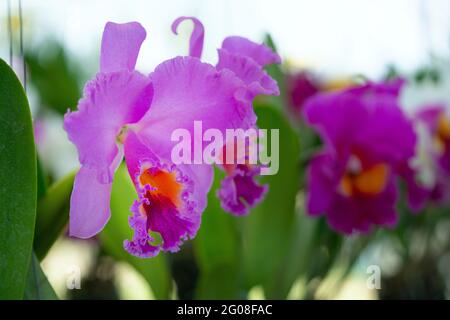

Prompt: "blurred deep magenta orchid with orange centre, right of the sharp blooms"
[304,83,416,234]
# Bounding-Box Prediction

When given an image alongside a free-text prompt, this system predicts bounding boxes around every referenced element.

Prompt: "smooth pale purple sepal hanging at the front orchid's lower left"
[69,167,112,238]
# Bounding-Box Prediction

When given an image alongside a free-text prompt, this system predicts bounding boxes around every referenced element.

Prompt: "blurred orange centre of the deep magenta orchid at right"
[339,157,389,197]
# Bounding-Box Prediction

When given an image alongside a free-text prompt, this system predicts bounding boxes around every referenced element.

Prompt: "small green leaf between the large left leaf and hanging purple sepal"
[34,171,75,261]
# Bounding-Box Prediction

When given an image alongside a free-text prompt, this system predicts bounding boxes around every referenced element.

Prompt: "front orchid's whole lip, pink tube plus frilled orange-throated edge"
[124,131,212,257]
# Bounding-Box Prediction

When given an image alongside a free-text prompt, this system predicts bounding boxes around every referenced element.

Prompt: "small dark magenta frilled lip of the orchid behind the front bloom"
[217,165,268,216]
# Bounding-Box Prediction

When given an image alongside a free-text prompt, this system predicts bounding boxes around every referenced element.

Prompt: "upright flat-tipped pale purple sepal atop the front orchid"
[100,22,146,73]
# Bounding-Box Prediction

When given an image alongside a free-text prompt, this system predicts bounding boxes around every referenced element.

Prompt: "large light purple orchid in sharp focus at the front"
[64,17,276,257]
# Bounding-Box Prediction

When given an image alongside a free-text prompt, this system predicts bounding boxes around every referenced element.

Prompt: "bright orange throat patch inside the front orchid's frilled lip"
[139,169,182,206]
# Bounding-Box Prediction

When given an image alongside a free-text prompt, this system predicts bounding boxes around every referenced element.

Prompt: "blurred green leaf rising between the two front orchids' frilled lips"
[194,169,245,299]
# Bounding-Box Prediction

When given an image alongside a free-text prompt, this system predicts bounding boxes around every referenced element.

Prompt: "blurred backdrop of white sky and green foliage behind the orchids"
[0,0,450,299]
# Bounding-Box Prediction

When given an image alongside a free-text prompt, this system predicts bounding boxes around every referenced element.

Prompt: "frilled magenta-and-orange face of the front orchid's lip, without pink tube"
[124,160,199,257]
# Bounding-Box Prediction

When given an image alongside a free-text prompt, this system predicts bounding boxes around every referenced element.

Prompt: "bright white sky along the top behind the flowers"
[0,0,450,77]
